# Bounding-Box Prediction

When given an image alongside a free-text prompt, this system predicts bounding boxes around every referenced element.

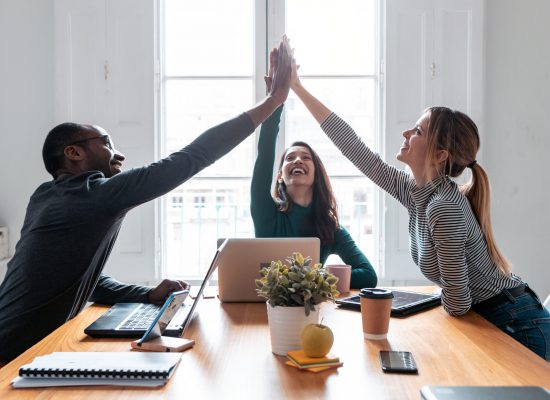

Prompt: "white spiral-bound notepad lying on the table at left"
[12,352,181,388]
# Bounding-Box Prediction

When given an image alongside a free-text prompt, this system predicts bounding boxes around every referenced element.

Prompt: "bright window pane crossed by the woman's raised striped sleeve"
[286,78,376,176]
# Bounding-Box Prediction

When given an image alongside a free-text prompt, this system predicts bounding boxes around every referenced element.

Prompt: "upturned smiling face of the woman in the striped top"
[396,113,430,176]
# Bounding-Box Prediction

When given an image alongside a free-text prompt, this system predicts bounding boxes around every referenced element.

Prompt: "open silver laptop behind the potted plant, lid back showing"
[217,238,321,302]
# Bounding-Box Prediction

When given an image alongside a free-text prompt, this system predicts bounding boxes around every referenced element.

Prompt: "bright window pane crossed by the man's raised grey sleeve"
[165,79,254,176]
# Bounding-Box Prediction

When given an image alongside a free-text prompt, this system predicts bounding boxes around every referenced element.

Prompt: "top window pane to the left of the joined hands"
[164,0,254,76]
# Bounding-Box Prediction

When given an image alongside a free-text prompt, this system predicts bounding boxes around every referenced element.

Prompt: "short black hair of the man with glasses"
[42,122,86,179]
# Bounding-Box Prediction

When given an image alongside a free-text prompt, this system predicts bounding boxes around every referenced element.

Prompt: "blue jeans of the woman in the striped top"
[476,288,550,361]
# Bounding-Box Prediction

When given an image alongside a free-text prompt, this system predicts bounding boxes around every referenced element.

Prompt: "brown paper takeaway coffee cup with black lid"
[359,288,393,340]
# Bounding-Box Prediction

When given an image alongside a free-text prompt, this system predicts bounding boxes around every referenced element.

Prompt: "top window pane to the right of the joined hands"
[286,0,376,75]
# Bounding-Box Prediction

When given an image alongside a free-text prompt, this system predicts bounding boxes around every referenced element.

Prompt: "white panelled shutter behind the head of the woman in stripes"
[381,0,484,285]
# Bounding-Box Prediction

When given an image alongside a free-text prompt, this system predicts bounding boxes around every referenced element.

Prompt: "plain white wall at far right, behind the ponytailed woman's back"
[488,0,550,298]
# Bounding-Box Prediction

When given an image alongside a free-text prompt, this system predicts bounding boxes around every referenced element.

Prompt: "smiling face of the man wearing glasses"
[81,125,125,178]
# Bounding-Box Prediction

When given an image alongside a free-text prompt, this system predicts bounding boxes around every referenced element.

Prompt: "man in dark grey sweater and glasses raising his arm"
[0,38,291,366]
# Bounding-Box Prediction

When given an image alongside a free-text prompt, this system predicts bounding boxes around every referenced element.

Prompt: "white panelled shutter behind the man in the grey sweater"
[53,0,157,284]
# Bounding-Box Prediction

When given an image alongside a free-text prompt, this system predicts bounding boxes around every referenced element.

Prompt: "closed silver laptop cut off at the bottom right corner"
[420,386,550,400]
